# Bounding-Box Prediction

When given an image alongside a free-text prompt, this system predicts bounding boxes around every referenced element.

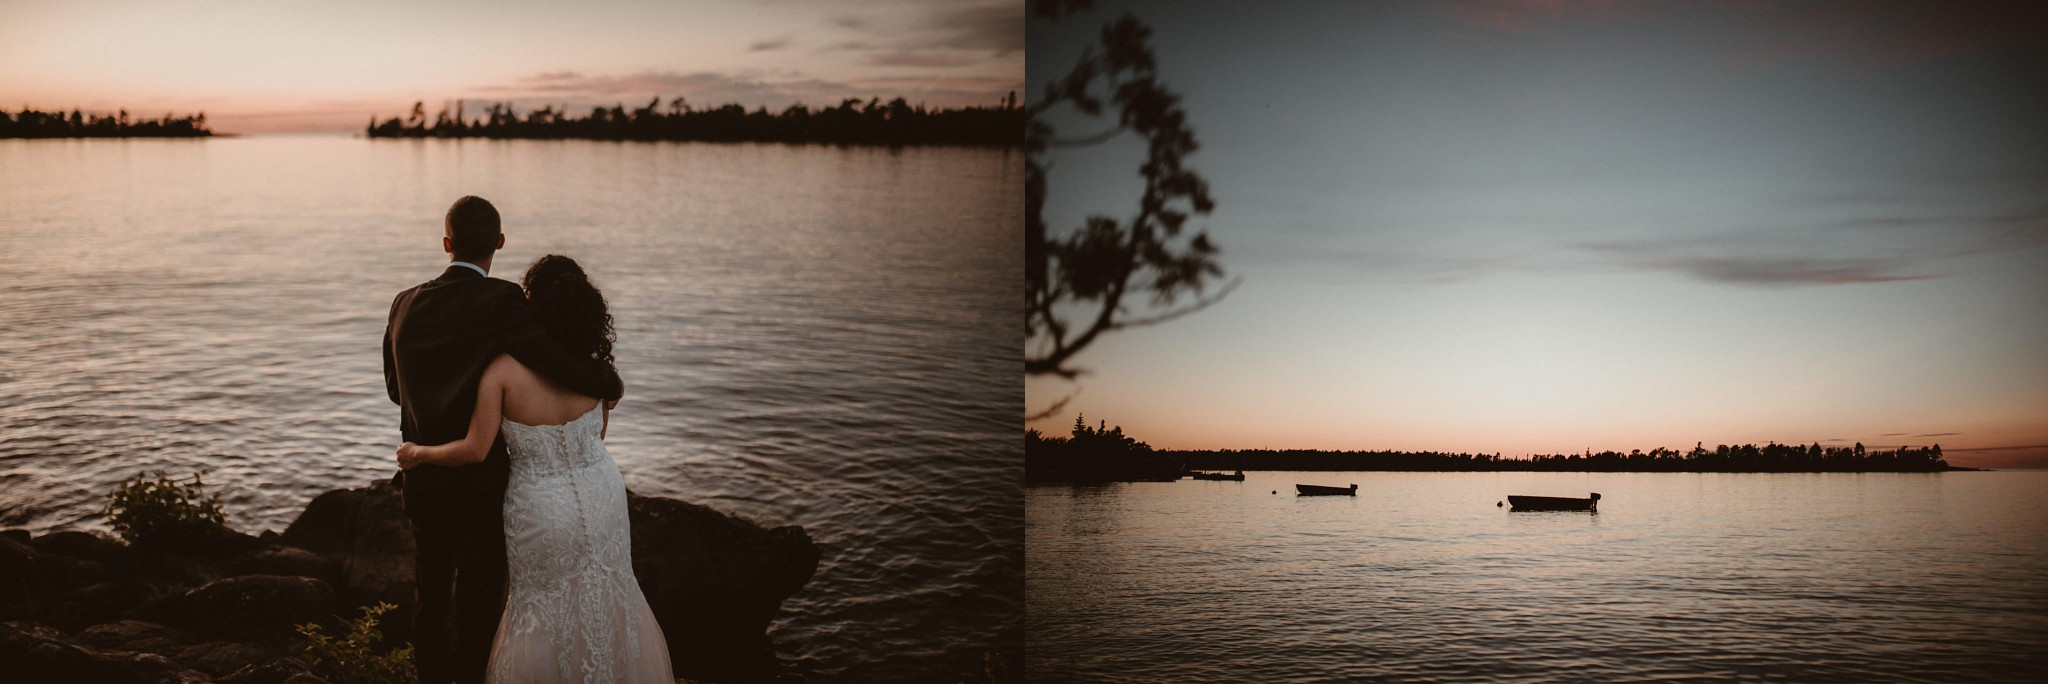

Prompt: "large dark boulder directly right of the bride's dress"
[627,496,817,680]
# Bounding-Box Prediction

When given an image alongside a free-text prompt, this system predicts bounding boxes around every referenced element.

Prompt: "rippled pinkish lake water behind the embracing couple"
[0,137,1024,680]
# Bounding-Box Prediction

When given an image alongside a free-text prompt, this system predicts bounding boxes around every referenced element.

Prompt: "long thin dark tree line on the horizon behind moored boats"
[1171,442,1958,473]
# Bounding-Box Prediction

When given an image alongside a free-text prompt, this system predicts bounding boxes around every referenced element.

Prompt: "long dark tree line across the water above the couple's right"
[367,92,1026,147]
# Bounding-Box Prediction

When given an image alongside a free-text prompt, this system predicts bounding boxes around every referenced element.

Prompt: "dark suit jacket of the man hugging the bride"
[383,264,625,516]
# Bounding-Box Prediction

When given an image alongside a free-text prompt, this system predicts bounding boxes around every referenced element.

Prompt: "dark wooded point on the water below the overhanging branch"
[1024,416,1184,481]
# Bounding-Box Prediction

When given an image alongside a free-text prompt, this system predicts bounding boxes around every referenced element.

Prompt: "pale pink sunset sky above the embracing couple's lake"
[0,0,1024,133]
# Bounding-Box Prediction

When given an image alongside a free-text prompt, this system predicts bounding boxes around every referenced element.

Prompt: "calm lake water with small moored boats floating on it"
[1024,471,2048,682]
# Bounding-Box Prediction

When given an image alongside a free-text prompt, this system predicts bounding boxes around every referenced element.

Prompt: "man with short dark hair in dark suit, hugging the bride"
[383,197,625,684]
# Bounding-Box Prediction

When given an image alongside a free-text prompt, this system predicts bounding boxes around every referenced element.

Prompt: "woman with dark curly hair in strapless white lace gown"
[397,254,674,682]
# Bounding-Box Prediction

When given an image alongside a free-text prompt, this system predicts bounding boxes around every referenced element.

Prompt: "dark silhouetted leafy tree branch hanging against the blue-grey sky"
[1024,0,1235,379]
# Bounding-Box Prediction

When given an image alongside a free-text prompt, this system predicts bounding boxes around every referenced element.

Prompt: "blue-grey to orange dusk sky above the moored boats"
[1026,0,2048,467]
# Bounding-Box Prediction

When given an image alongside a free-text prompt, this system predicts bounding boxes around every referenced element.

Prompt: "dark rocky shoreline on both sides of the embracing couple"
[0,481,819,684]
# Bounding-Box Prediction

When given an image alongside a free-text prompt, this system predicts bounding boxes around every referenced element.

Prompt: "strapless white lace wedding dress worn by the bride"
[487,408,674,682]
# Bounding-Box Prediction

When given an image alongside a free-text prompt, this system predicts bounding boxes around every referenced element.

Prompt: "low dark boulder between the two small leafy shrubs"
[137,575,336,639]
